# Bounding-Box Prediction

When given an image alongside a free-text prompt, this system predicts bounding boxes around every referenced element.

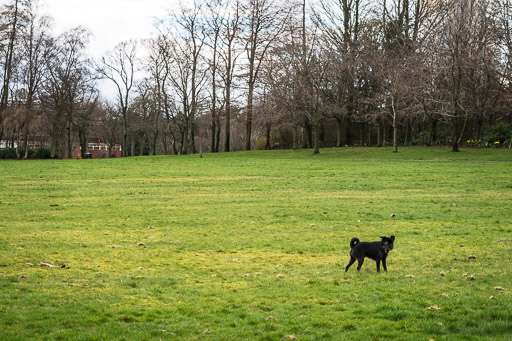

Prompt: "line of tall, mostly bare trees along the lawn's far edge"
[0,0,512,158]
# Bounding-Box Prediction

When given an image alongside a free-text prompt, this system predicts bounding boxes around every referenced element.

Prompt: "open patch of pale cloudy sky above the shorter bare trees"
[40,0,179,58]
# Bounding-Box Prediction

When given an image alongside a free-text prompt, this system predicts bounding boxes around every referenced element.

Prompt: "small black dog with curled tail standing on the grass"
[345,236,395,272]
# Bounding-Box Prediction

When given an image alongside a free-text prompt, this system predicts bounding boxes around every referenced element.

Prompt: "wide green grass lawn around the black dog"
[0,148,512,340]
